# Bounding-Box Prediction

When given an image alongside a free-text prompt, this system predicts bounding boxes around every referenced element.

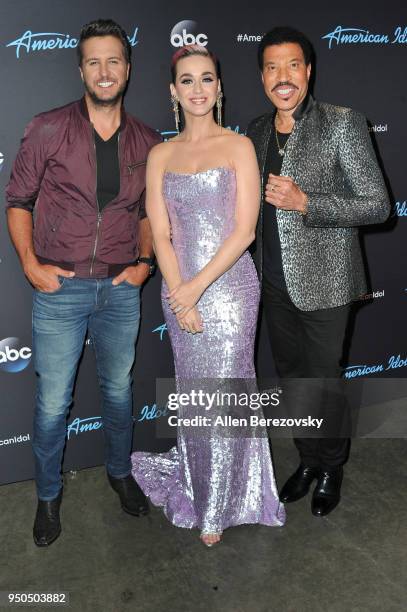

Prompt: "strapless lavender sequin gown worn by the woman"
[132,167,285,533]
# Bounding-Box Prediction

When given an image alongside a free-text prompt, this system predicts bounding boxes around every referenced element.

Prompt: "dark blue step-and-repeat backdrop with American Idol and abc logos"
[0,0,407,484]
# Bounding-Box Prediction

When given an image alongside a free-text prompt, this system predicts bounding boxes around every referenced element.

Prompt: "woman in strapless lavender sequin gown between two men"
[132,46,285,545]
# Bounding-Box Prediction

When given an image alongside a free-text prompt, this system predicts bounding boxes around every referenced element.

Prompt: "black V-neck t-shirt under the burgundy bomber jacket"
[95,128,120,211]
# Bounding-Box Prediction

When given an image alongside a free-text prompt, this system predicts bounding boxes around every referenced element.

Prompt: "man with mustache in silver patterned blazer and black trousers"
[247,27,390,516]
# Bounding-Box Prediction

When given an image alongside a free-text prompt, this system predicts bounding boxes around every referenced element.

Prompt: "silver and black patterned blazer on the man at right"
[247,96,390,310]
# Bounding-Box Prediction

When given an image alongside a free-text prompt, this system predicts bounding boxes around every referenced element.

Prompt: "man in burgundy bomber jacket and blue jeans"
[7,20,160,546]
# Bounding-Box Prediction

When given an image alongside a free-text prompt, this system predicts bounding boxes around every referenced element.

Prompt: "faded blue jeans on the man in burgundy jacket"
[33,277,140,501]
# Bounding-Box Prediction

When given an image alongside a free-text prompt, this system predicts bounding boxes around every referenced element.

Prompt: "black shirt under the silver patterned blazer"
[263,128,290,290]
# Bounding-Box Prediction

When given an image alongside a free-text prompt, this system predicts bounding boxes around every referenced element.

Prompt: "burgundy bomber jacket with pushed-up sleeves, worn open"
[6,98,161,278]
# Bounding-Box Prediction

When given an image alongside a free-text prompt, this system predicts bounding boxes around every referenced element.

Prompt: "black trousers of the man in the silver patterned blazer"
[262,279,350,469]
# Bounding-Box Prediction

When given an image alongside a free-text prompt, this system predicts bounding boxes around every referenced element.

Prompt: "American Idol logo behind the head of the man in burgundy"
[6,27,138,59]
